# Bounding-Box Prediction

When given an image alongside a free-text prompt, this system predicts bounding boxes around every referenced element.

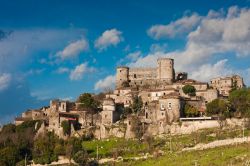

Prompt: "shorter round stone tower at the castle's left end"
[116,66,129,88]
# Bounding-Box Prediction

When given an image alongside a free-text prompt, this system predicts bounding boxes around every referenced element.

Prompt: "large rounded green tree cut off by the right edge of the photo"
[229,88,250,118]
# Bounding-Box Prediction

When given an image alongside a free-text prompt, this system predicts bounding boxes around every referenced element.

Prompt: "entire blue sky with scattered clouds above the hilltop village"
[0,0,250,123]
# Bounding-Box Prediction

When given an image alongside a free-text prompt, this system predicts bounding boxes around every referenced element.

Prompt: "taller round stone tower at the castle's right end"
[157,58,174,84]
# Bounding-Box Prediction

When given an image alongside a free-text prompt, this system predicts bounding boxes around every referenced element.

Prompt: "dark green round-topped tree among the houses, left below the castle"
[77,93,100,125]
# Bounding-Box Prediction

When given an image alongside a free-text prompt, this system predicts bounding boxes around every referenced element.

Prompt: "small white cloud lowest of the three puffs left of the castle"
[69,63,95,81]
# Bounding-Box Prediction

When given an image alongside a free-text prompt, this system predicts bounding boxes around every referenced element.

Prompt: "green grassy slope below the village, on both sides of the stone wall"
[82,129,250,166]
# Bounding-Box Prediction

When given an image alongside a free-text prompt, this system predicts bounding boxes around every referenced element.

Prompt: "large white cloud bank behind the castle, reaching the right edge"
[129,7,250,83]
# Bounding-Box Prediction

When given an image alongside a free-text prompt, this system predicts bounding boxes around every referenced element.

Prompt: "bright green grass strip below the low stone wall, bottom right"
[121,144,250,166]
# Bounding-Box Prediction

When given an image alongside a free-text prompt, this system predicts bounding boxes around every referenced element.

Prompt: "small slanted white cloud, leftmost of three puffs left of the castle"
[57,39,89,59]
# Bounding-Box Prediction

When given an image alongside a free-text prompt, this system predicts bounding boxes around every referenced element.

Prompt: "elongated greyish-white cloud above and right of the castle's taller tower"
[147,13,201,39]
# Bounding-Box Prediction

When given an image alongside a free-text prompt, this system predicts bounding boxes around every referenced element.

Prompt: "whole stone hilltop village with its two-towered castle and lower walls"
[15,58,245,139]
